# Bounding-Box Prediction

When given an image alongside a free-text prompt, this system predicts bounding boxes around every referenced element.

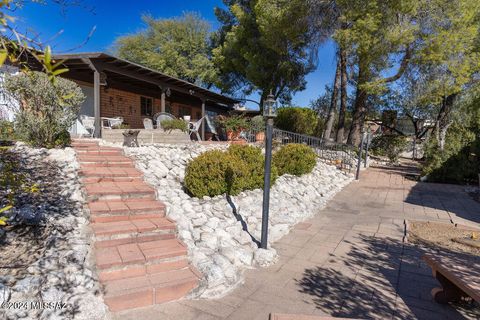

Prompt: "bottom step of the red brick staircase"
[104,269,198,312]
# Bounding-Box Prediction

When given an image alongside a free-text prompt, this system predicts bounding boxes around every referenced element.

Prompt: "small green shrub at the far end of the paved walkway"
[370,134,408,163]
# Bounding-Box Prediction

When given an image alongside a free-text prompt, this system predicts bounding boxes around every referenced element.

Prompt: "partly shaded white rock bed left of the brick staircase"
[0,143,109,320]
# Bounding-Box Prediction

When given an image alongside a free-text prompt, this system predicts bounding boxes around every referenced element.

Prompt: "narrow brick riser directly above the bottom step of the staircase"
[98,256,189,283]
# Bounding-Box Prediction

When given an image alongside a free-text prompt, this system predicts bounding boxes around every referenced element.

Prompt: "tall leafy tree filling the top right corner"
[382,0,480,151]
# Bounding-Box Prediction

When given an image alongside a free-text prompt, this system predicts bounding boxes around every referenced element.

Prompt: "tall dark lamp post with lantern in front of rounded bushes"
[260,91,277,249]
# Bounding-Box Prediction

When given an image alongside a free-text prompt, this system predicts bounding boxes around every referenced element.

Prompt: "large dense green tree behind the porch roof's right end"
[213,0,315,105]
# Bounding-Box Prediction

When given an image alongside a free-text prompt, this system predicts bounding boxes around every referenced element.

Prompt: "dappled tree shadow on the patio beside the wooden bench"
[297,234,480,319]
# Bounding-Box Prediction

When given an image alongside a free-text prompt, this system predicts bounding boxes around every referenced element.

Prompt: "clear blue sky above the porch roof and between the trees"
[14,0,335,106]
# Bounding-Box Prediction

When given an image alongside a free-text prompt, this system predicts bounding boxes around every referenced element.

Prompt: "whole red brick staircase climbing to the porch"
[72,139,199,312]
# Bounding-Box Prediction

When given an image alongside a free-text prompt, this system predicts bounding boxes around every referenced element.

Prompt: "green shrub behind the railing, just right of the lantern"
[275,107,318,136]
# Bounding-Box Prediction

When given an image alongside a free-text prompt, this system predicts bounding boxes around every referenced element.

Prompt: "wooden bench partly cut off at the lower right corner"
[423,253,480,304]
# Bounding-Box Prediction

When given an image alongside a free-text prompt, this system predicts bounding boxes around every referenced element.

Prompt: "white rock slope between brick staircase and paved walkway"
[124,144,352,298]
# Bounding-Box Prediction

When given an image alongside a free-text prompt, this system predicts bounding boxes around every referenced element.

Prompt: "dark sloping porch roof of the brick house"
[53,52,239,109]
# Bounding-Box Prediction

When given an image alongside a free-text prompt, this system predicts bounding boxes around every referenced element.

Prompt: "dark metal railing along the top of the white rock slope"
[246,128,358,171]
